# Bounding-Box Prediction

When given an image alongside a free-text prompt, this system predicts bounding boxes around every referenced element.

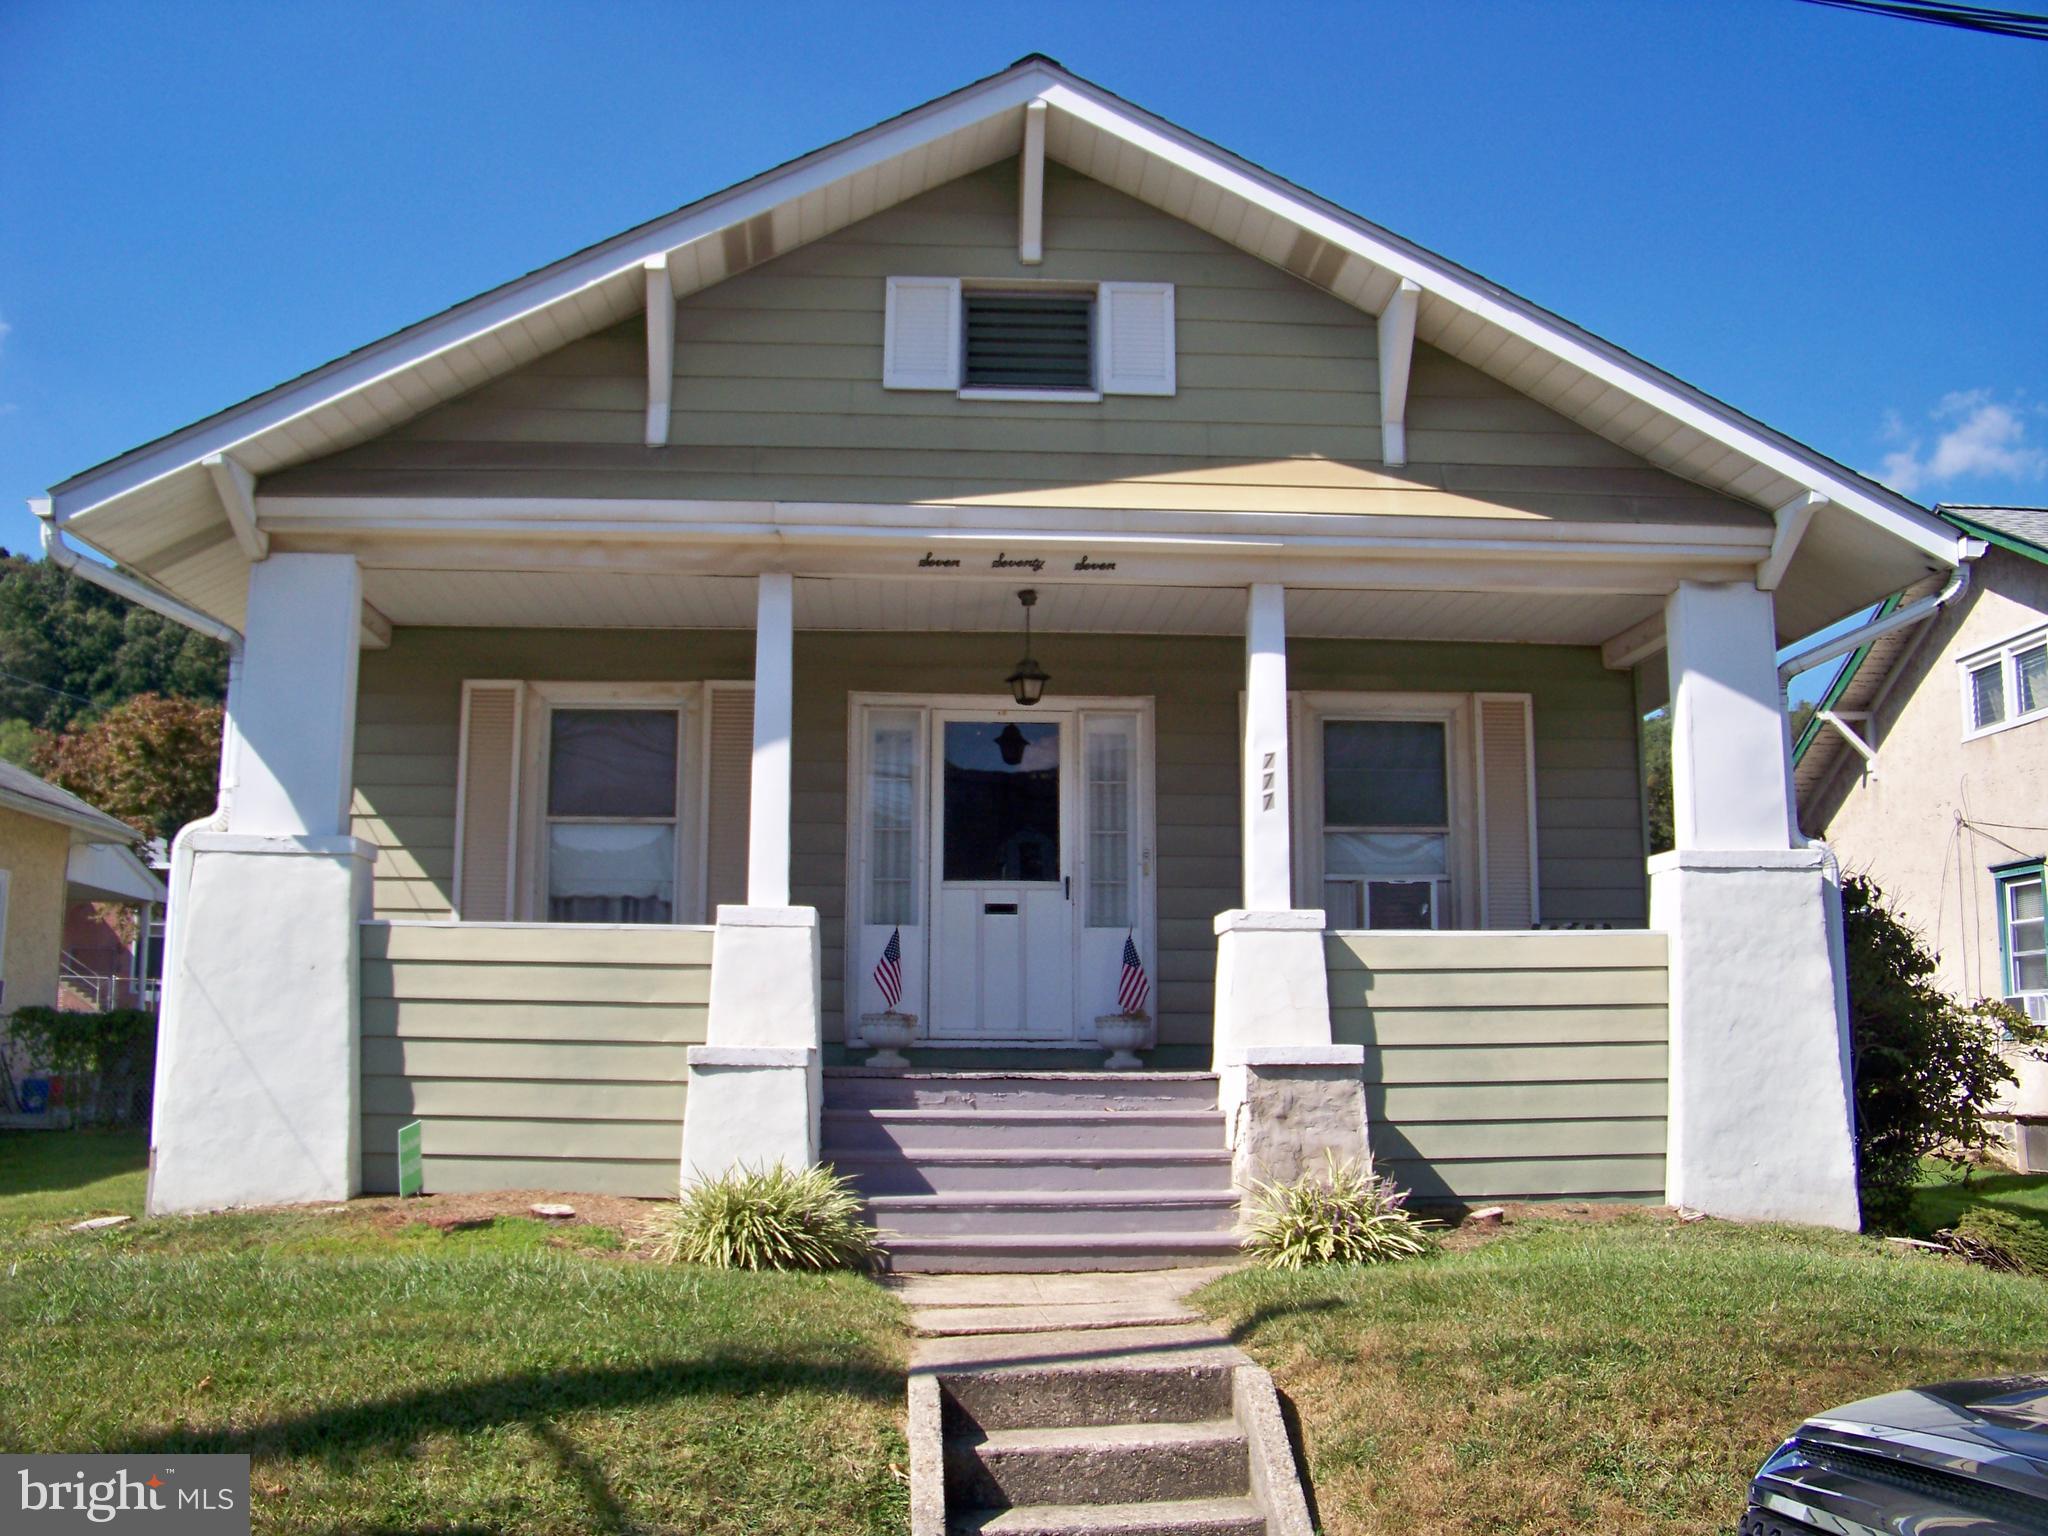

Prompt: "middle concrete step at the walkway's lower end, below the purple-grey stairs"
[946,1419,1251,1507]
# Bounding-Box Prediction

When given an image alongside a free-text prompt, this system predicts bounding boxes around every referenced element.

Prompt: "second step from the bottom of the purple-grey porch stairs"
[868,1186,1237,1251]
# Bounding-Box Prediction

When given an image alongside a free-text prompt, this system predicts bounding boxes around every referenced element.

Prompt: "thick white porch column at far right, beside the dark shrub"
[1651,582,1858,1229]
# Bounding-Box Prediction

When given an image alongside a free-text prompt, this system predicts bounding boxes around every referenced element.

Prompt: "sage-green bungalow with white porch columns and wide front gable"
[43,57,1958,1262]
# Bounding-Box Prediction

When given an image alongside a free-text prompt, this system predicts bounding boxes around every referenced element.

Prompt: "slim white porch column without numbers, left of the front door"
[682,571,823,1184]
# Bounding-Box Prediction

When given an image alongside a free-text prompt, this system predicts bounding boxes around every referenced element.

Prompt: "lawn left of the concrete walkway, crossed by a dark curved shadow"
[0,1133,907,1536]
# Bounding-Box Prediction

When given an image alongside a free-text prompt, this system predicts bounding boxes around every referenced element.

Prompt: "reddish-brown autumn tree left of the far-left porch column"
[33,694,221,838]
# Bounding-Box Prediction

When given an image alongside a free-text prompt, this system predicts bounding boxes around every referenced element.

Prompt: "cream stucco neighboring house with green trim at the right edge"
[1794,506,2048,1169]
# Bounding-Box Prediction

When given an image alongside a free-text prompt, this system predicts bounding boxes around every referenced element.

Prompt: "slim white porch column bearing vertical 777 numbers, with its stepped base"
[1214,582,1366,1186]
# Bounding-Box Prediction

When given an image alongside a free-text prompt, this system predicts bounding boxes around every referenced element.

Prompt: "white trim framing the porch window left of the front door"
[514,682,709,928]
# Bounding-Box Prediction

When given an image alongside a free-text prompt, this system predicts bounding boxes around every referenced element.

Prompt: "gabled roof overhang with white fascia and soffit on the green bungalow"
[53,55,1956,635]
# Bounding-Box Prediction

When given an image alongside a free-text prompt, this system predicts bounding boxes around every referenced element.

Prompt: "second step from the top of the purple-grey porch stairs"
[823,1108,1223,1161]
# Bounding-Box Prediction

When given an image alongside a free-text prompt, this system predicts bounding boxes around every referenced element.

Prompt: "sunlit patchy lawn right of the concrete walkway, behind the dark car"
[1198,1214,2048,1536]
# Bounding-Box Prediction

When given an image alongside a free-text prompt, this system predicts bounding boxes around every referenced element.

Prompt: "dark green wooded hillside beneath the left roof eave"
[0,551,227,731]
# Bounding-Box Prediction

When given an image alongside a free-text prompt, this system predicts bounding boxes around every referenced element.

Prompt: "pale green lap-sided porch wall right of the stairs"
[1327,932,1669,1200]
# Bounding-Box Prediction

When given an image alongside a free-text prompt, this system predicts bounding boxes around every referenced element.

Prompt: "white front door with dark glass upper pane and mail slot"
[932,709,1075,1040]
